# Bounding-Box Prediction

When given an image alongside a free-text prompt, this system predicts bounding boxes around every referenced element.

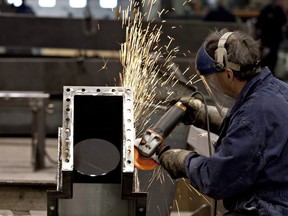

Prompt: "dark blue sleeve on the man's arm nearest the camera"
[185,119,265,199]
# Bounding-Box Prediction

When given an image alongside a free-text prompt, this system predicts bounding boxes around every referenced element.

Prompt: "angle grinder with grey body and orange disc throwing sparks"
[134,101,187,170]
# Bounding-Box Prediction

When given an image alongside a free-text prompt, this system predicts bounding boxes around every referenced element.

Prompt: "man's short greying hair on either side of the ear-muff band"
[204,29,261,81]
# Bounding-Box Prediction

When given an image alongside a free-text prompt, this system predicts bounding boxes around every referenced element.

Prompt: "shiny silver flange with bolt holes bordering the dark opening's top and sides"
[61,86,135,172]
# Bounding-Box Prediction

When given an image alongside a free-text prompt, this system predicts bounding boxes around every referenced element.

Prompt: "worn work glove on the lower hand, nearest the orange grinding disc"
[159,149,192,179]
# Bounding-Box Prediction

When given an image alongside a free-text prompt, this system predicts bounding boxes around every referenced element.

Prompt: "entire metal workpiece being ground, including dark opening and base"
[47,86,147,216]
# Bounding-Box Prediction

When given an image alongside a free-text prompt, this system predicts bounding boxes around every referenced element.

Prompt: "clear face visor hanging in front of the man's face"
[200,73,235,117]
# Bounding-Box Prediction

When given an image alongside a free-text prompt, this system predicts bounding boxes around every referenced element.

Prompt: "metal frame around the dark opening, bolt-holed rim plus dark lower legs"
[47,86,147,216]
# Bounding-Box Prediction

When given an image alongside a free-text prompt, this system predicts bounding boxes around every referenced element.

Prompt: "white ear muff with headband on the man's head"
[215,32,233,68]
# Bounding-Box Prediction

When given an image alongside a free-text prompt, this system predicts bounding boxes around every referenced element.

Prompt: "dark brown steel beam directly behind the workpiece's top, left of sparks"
[0,58,122,95]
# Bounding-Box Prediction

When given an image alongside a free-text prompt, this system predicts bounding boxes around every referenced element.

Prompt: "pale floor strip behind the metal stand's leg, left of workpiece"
[0,138,57,183]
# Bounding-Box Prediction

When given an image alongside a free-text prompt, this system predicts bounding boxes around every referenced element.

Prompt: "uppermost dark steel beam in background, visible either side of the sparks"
[0,15,247,52]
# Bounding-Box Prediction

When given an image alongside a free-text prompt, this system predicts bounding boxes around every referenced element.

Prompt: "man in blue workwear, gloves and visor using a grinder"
[158,29,288,216]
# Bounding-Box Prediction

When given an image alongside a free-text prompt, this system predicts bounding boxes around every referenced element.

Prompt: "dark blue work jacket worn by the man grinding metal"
[185,67,288,216]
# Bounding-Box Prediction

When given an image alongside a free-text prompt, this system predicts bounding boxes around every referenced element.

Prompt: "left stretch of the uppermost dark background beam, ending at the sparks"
[0,15,125,50]
